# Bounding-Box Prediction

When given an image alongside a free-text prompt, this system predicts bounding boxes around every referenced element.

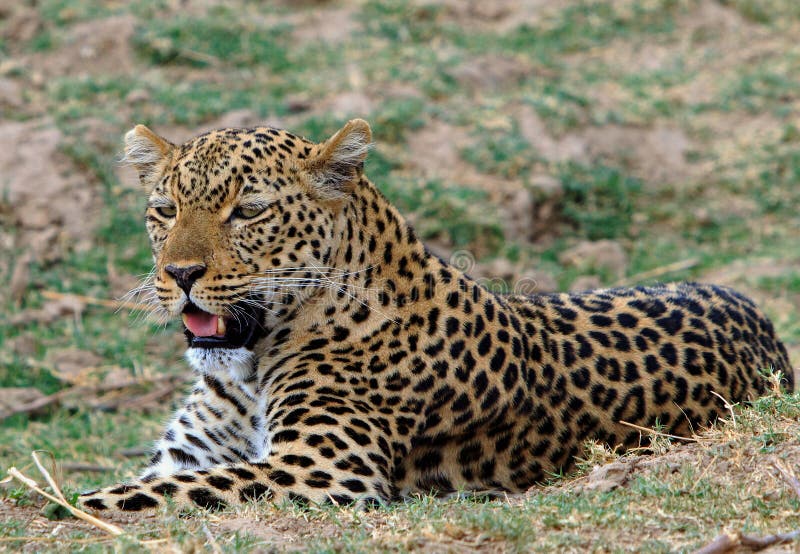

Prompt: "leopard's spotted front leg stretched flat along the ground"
[81,402,393,511]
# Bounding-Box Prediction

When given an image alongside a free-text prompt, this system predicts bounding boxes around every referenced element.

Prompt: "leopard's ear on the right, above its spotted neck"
[305,119,372,200]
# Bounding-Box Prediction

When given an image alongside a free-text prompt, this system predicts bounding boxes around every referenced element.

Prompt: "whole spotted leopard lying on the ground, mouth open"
[80,119,795,511]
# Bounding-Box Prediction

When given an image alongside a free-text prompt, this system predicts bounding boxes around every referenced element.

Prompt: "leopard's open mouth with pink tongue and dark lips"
[181,302,264,349]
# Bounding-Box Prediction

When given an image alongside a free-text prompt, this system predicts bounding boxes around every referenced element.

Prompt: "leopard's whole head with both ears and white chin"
[125,119,371,373]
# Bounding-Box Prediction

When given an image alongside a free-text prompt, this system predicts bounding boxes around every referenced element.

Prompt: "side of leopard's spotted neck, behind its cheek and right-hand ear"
[265,178,493,347]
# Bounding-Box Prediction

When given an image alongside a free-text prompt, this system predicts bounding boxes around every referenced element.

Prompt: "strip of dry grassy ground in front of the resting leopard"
[0,388,800,552]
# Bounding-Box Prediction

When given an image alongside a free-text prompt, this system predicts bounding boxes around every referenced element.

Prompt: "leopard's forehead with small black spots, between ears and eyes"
[160,127,316,210]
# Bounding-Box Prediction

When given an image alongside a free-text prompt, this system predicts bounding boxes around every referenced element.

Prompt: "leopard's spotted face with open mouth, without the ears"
[146,132,333,340]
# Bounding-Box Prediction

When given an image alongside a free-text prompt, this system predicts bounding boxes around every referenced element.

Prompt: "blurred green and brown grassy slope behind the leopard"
[0,0,800,485]
